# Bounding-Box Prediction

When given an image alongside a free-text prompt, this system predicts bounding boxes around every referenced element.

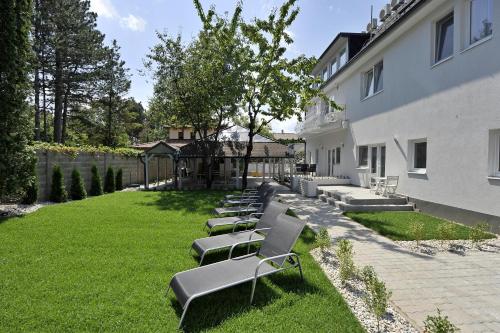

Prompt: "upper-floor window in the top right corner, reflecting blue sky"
[469,0,493,44]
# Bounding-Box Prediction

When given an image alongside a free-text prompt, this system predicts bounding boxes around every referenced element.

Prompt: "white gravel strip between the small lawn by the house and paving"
[395,238,500,256]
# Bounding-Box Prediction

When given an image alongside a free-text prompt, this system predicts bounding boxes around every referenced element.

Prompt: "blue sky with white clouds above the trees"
[91,0,388,132]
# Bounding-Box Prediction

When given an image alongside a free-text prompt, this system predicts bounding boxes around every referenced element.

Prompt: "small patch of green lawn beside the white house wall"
[345,212,495,241]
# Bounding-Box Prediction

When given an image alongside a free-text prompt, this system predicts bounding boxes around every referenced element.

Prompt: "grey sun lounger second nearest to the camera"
[191,201,288,266]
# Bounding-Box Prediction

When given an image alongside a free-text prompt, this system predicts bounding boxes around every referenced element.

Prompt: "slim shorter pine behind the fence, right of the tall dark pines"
[98,40,130,146]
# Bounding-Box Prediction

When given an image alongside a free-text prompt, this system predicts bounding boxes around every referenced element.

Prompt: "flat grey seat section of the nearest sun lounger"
[170,256,277,308]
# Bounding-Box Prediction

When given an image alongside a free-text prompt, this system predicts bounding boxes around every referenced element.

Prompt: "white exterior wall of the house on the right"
[307,0,500,216]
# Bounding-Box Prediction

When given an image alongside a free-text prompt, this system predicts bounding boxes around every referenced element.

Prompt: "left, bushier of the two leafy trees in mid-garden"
[146,0,244,188]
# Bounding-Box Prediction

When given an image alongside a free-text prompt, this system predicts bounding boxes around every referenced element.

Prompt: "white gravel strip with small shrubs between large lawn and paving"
[311,249,419,333]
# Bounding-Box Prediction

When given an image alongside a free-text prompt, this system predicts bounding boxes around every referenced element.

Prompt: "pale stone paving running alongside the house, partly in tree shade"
[279,192,500,332]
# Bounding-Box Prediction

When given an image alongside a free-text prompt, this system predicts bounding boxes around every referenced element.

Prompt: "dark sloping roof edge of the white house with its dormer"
[320,0,431,86]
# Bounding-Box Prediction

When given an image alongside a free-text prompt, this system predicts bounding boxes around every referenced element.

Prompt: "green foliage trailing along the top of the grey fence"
[33,142,141,158]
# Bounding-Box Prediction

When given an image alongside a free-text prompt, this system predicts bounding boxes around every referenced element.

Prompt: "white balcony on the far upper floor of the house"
[295,110,348,136]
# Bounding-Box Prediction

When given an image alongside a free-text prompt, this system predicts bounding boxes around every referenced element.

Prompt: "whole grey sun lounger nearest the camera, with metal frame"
[167,214,305,328]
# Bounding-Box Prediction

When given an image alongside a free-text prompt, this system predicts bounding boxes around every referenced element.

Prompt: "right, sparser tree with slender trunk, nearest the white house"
[237,0,339,188]
